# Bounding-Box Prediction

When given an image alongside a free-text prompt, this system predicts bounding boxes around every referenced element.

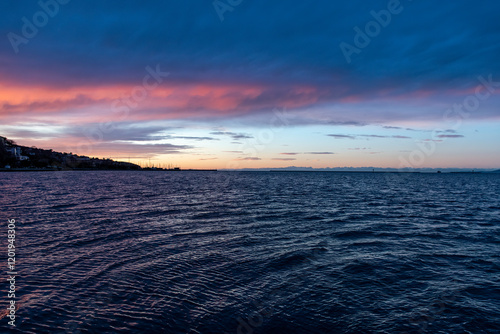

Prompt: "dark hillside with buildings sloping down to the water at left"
[0,137,141,170]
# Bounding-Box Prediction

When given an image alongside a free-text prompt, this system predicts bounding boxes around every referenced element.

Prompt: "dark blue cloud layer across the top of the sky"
[0,0,500,91]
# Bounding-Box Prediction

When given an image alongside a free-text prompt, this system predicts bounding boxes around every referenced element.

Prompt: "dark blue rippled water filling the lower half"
[0,171,500,333]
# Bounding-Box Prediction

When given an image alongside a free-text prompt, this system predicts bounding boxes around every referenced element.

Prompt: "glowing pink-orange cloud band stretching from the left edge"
[0,82,324,122]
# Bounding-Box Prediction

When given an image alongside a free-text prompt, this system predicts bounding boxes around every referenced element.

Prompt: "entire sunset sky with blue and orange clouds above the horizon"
[0,0,500,169]
